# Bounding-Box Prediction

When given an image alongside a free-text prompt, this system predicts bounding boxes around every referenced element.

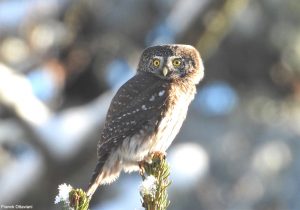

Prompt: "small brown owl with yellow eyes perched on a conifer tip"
[87,45,204,197]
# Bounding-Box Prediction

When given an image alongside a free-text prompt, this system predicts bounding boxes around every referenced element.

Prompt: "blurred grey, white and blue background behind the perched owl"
[0,0,300,210]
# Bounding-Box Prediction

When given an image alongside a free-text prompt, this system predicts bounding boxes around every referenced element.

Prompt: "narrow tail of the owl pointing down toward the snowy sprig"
[86,161,104,199]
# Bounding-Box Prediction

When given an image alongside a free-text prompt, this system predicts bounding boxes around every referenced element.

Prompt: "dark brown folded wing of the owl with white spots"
[98,73,169,154]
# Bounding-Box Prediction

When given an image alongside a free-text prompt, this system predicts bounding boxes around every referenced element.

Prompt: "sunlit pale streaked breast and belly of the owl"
[150,83,196,153]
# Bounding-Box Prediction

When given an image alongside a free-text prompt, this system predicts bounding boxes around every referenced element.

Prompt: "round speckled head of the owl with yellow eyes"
[138,44,204,84]
